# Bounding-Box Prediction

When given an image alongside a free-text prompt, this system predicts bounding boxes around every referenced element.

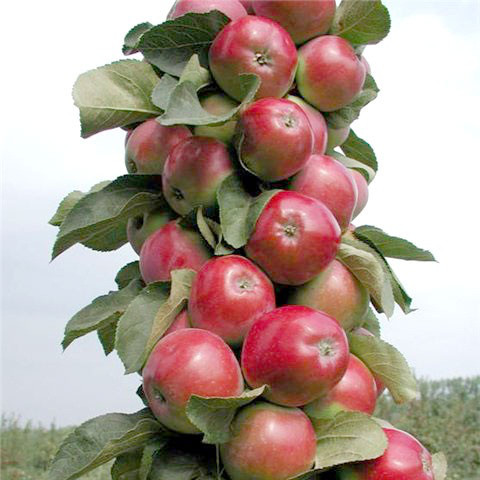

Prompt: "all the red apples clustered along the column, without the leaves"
[113,0,434,480]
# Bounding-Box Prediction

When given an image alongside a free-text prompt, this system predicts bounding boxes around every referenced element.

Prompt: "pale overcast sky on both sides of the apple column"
[0,0,480,425]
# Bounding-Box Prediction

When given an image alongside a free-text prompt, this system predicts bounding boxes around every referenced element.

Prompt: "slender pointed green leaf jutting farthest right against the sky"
[354,225,436,262]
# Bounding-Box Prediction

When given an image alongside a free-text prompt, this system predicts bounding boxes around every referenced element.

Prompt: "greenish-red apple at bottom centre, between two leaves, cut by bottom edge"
[220,402,316,480]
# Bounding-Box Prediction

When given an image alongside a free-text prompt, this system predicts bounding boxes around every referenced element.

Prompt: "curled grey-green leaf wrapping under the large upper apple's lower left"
[158,74,260,126]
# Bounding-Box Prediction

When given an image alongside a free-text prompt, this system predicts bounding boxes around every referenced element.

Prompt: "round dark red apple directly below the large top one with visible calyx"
[237,98,313,182]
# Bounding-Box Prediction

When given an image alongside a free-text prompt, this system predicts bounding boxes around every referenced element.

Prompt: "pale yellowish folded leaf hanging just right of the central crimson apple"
[337,242,394,317]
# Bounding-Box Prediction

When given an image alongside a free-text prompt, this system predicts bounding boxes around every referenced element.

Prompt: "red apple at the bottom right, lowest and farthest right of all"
[337,428,435,480]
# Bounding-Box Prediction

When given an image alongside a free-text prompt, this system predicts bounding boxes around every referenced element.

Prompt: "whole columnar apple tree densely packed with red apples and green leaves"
[50,0,446,480]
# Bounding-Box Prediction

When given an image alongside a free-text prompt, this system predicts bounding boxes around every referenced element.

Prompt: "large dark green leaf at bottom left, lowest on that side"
[48,409,167,480]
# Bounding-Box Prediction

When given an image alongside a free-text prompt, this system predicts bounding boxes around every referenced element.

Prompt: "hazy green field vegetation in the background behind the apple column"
[1,377,480,480]
